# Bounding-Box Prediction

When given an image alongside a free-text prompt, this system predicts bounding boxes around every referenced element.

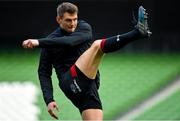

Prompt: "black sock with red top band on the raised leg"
[101,29,140,53]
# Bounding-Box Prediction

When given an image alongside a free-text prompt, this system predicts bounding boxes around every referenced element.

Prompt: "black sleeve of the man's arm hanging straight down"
[38,49,54,105]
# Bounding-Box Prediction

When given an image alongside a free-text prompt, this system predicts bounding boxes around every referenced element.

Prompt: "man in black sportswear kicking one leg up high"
[22,2,151,120]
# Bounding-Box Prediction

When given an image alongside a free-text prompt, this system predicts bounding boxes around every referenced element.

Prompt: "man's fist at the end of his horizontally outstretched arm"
[22,39,39,48]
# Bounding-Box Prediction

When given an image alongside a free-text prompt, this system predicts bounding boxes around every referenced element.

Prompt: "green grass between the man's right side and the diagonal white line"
[101,54,180,119]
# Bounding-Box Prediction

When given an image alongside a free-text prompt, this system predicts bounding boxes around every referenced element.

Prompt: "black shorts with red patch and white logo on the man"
[59,65,102,113]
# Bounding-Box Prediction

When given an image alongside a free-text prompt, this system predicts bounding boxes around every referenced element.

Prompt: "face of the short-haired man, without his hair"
[56,12,78,33]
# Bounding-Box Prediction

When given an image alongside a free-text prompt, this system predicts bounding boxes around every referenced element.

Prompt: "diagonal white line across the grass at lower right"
[117,78,180,121]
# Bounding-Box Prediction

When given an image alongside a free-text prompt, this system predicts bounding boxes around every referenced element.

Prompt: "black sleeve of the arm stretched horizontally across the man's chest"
[38,21,92,48]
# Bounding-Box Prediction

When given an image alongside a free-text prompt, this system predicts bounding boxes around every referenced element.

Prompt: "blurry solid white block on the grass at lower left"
[0,81,40,121]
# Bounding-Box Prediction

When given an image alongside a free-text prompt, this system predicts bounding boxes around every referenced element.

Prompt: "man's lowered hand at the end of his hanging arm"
[48,101,59,119]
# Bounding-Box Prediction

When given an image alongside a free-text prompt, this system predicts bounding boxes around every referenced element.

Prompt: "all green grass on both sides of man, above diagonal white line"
[0,50,180,120]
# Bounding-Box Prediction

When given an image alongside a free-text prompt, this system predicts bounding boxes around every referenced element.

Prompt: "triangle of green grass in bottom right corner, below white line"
[135,90,180,121]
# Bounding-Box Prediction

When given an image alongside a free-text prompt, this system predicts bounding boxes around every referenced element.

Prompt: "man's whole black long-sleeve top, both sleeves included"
[38,20,99,105]
